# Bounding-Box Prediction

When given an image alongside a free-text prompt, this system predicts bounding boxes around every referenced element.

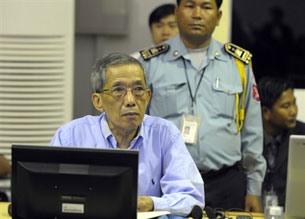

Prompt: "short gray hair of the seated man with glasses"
[91,53,146,93]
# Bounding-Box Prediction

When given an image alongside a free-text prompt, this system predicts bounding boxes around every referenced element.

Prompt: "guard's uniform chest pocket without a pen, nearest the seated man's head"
[150,82,190,117]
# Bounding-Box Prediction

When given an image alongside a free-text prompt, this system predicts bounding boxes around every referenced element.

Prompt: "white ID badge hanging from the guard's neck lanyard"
[181,114,201,144]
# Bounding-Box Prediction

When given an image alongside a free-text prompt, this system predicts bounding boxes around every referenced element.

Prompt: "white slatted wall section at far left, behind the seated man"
[0,0,74,159]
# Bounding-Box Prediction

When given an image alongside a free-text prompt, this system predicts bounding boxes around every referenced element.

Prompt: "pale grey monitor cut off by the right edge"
[285,135,305,218]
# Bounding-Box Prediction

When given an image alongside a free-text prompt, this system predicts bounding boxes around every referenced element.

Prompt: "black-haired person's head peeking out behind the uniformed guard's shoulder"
[149,4,178,45]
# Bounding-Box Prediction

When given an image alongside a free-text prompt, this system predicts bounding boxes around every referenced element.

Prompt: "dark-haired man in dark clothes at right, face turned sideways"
[258,77,305,206]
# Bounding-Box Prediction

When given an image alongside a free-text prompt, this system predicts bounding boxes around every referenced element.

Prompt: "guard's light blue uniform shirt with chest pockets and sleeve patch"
[140,34,266,195]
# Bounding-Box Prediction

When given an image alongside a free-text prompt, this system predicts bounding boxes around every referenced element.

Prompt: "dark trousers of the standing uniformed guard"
[201,162,247,211]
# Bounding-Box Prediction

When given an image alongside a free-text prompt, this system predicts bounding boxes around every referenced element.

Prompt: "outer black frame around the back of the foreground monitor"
[11,145,139,219]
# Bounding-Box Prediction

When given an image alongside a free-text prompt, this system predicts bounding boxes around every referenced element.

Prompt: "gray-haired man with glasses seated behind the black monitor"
[50,53,204,218]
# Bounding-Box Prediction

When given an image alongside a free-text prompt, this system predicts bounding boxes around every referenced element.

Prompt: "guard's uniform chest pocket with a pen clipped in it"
[212,81,243,118]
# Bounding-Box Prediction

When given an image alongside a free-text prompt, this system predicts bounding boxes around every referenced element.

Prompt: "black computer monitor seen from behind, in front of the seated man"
[11,145,139,219]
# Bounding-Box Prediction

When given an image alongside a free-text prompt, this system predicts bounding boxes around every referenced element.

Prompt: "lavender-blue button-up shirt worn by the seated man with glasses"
[50,114,204,214]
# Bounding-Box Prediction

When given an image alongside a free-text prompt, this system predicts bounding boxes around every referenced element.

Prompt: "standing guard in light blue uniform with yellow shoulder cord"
[140,0,266,211]
